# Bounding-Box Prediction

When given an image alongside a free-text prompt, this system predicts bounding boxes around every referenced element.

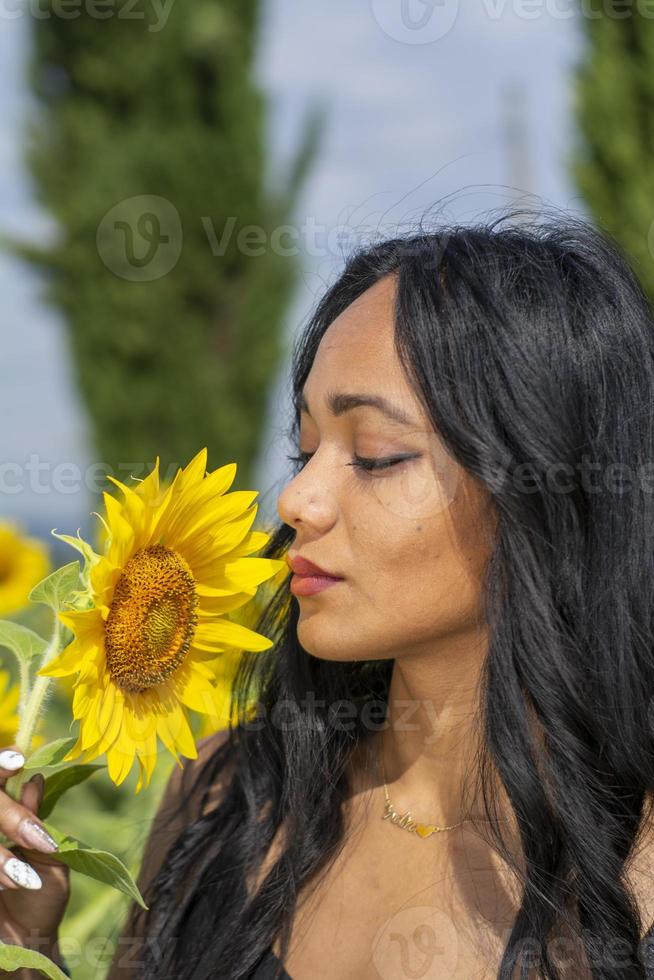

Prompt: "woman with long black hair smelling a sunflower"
[0,215,654,980]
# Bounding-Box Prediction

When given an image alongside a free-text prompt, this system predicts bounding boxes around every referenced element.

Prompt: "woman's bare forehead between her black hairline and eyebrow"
[304,276,418,400]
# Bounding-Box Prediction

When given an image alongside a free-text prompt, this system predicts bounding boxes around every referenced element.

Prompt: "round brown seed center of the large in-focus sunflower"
[105,544,198,693]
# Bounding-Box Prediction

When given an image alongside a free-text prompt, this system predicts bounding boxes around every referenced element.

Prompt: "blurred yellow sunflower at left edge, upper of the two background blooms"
[0,521,50,616]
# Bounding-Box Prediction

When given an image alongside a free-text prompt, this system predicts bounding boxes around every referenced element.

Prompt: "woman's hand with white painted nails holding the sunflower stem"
[0,746,70,956]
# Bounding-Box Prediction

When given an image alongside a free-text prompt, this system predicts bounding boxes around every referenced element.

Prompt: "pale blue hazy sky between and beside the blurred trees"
[0,0,584,534]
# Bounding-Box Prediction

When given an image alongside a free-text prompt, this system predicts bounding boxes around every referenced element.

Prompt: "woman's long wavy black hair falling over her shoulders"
[135,210,654,980]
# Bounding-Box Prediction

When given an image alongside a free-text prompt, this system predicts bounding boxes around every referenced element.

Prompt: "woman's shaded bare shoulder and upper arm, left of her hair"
[106,730,229,980]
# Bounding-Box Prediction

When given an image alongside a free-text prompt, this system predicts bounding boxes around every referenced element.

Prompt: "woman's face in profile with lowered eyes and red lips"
[277,275,498,660]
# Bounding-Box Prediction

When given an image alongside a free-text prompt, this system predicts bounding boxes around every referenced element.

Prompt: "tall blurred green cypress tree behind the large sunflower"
[5,0,323,489]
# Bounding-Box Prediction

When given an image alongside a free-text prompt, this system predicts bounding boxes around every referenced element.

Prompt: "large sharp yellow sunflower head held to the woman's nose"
[39,448,284,792]
